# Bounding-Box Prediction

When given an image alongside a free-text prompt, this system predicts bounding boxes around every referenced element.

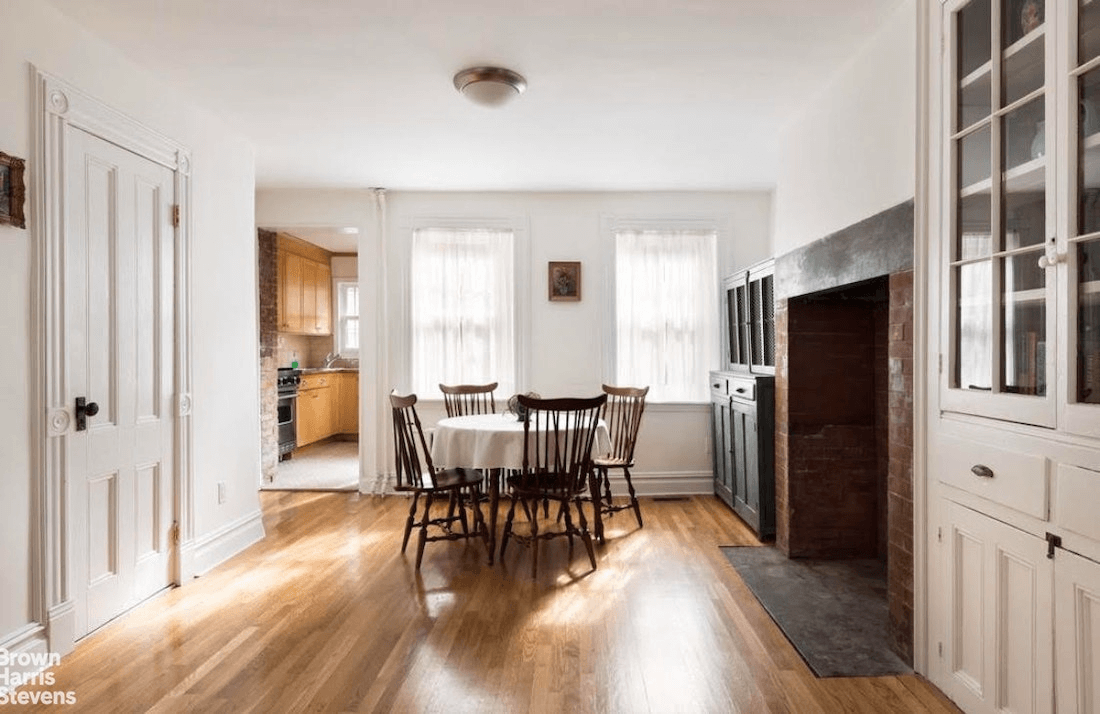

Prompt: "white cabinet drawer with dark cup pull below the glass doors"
[935,437,1051,520]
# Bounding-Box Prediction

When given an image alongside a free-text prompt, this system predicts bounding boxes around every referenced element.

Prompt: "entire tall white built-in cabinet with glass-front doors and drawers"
[927,0,1100,712]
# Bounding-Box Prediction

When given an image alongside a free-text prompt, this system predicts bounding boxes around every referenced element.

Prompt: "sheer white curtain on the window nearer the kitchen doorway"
[410,228,516,397]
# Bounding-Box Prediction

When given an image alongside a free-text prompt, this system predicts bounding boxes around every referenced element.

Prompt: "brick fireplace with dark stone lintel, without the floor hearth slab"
[776,202,913,663]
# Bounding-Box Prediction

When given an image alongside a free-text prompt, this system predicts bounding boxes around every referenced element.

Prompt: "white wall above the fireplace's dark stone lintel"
[776,0,916,255]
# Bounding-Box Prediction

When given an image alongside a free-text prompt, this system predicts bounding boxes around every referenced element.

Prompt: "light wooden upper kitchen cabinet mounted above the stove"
[278,234,332,334]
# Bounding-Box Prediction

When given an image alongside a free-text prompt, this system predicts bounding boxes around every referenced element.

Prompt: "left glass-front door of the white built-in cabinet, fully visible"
[942,0,1060,427]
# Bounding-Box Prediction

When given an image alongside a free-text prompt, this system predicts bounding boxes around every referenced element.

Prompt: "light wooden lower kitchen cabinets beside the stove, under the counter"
[297,372,359,447]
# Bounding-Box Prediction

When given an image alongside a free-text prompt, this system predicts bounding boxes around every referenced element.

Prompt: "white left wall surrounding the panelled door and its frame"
[0,0,260,642]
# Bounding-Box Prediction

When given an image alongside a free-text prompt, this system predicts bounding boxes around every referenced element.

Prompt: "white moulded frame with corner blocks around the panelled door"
[30,66,195,655]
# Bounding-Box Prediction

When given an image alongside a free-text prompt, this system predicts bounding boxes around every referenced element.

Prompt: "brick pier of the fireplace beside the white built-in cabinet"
[887,271,913,664]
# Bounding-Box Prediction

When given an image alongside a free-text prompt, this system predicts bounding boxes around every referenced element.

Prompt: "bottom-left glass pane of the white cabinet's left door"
[953,261,993,391]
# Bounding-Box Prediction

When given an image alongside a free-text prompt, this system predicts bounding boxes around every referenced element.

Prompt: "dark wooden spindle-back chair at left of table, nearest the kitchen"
[389,394,490,570]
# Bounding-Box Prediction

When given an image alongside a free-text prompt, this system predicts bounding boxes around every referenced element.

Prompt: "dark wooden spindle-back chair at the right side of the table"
[590,384,649,542]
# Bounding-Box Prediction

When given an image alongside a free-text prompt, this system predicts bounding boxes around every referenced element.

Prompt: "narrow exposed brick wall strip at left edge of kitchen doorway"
[256,230,278,481]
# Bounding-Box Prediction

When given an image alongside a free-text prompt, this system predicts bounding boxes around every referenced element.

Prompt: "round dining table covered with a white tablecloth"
[431,413,612,564]
